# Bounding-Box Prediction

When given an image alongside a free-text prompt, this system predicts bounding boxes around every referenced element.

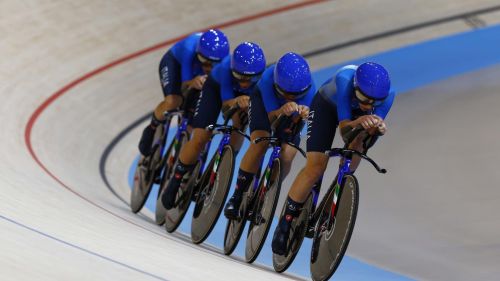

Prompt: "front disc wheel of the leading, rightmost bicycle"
[311,175,359,280]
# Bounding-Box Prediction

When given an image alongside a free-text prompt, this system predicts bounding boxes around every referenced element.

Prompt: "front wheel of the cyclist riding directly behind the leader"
[245,158,281,263]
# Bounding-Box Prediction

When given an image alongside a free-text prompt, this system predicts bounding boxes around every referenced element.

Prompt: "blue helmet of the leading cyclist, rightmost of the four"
[354,62,391,100]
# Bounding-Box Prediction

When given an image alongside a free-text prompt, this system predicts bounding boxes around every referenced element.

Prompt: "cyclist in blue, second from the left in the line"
[162,42,266,210]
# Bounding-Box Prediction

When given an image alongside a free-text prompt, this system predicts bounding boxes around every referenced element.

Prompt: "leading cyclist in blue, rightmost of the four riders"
[272,62,395,255]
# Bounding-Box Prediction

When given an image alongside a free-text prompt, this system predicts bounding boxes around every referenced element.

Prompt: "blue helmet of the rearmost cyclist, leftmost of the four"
[196,29,229,61]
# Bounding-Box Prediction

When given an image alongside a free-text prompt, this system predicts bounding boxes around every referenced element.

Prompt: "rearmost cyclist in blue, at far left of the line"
[139,29,229,156]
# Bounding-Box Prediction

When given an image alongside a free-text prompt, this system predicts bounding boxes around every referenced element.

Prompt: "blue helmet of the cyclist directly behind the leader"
[274,52,312,95]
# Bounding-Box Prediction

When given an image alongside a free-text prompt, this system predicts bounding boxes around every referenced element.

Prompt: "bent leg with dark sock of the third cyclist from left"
[224,91,271,219]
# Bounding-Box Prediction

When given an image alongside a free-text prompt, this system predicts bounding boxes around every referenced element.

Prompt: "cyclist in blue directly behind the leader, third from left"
[224,52,316,219]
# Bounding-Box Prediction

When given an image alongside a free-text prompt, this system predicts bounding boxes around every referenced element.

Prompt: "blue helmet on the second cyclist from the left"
[231,42,266,76]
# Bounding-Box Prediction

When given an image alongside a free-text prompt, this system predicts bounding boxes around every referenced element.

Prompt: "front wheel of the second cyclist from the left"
[191,145,234,244]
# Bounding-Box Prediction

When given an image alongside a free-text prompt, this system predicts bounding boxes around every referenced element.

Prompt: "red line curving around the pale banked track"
[24,0,328,230]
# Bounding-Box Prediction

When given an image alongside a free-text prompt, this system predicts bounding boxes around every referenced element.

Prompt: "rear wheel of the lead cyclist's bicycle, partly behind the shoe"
[273,194,313,272]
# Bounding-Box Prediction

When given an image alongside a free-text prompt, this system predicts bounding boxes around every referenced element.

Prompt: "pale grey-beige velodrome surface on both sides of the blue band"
[0,1,500,280]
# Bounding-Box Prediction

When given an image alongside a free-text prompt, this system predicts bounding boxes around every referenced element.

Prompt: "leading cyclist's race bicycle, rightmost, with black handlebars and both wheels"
[273,127,387,280]
